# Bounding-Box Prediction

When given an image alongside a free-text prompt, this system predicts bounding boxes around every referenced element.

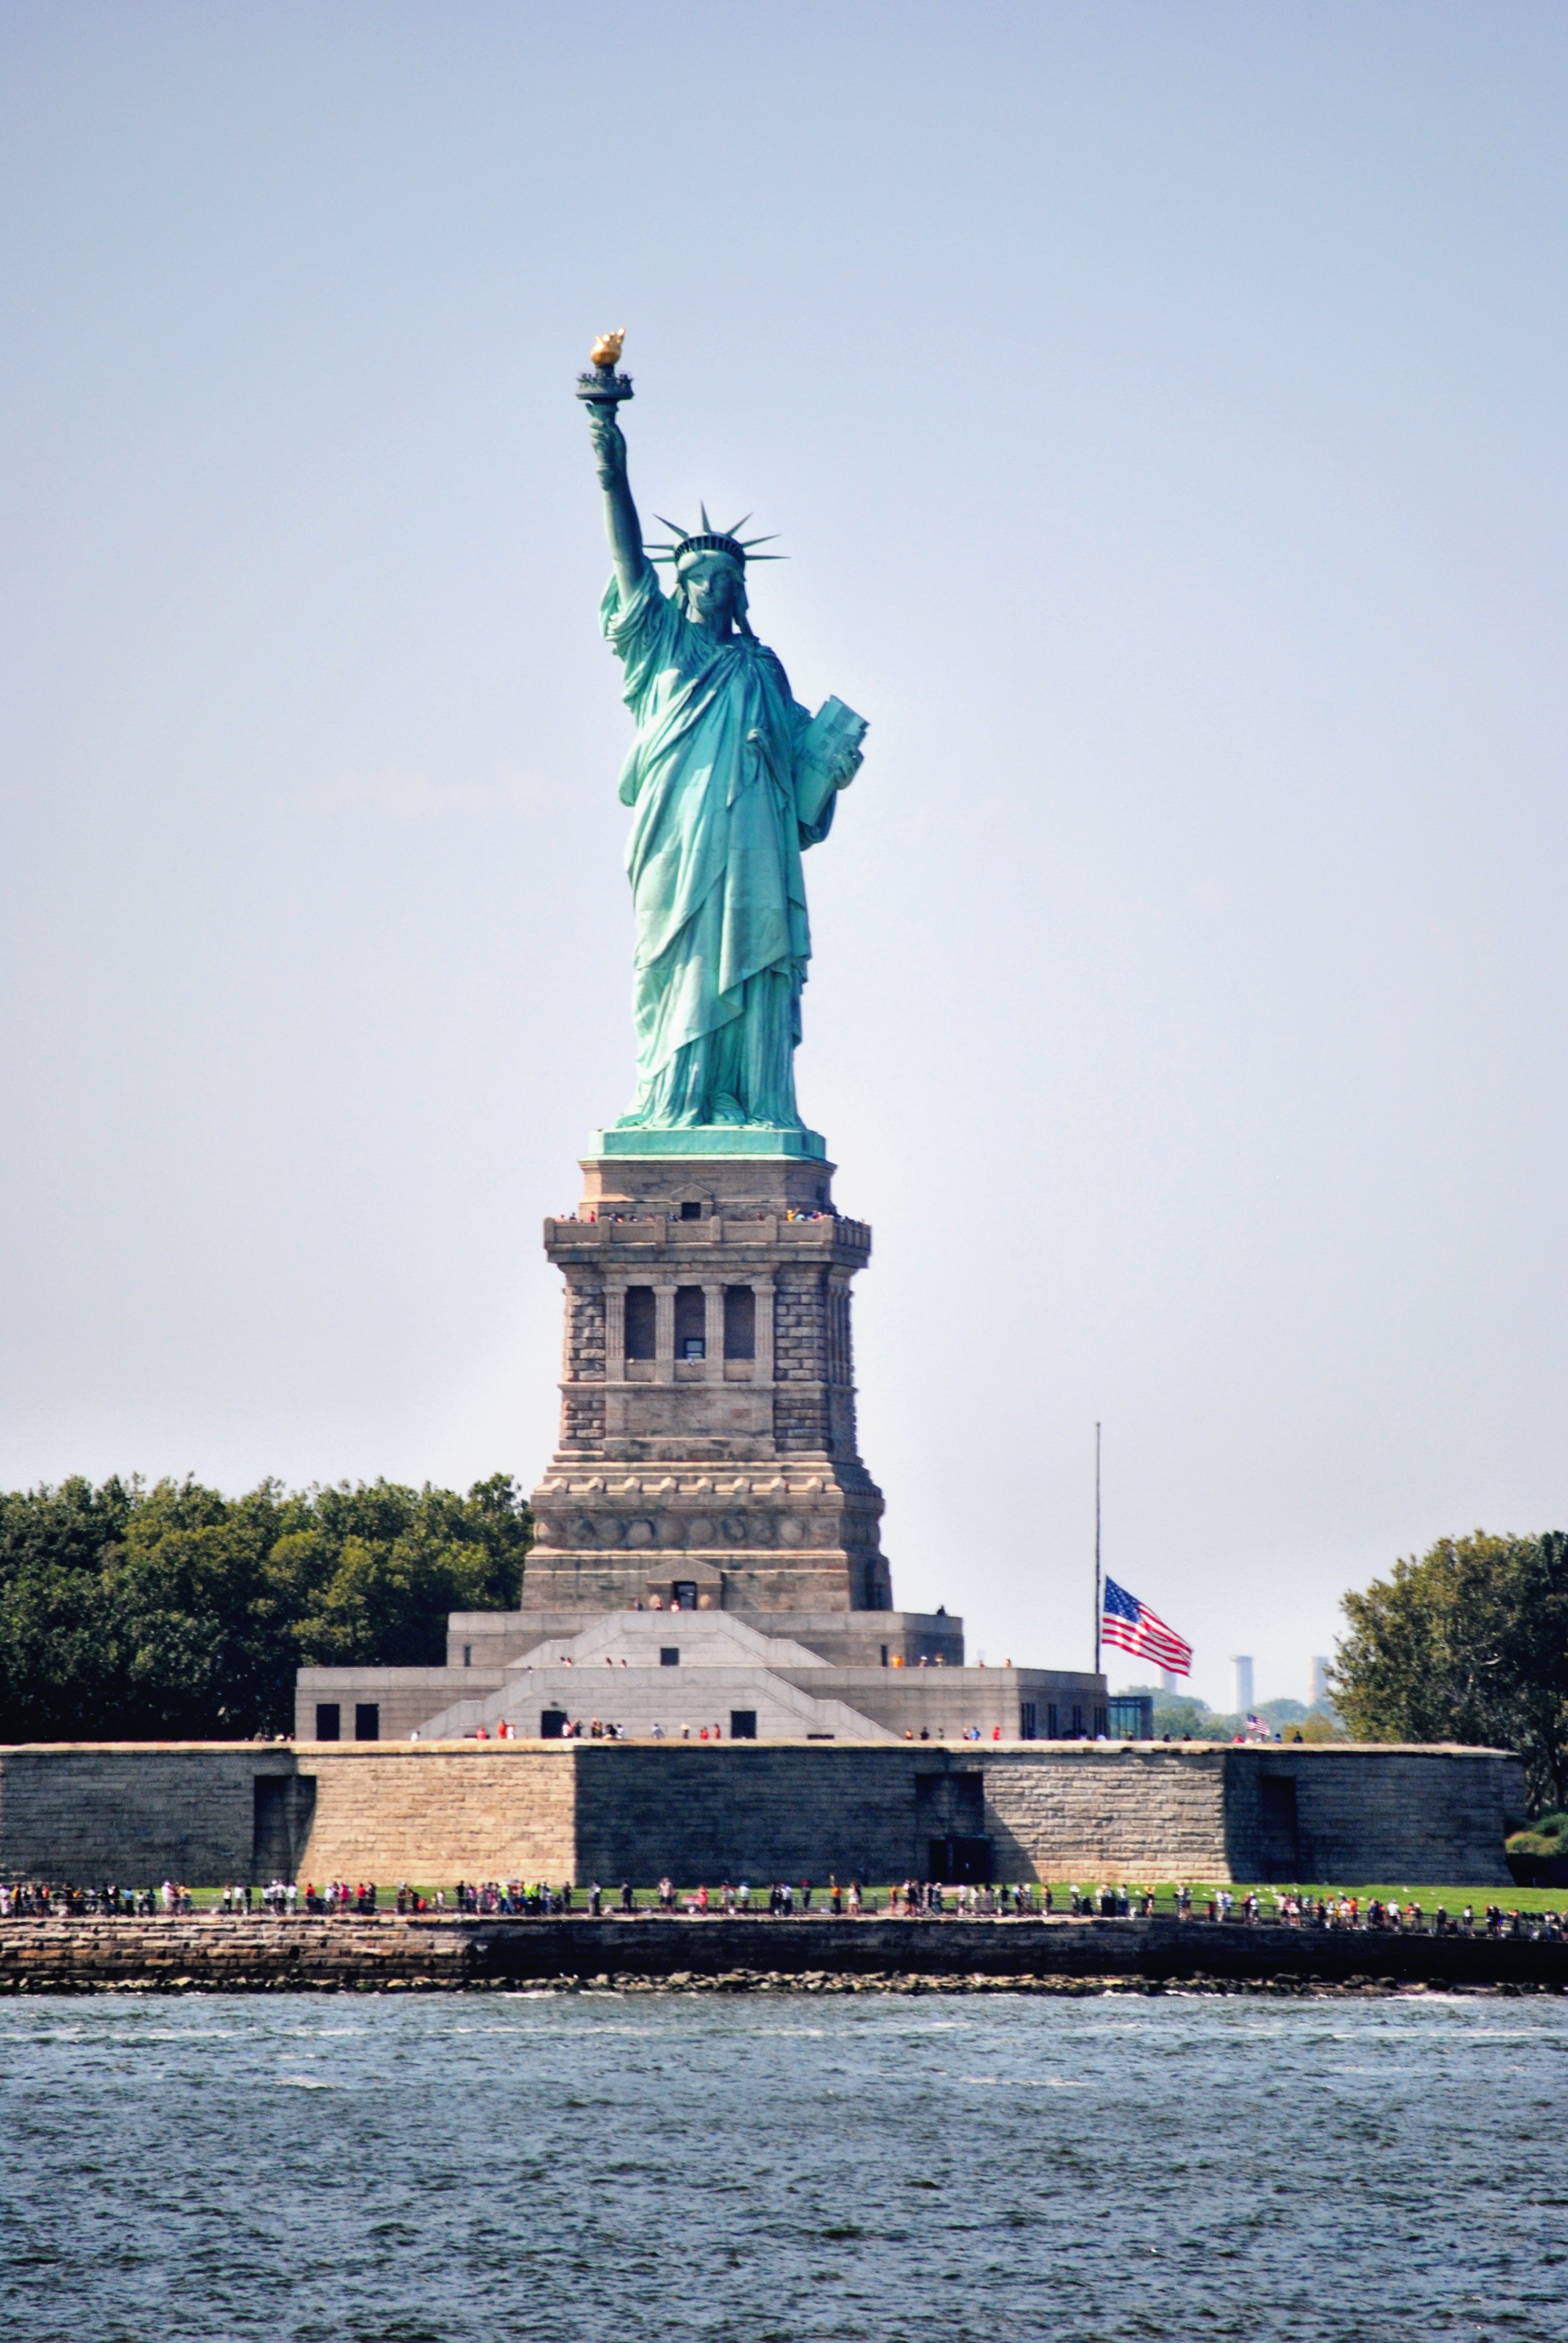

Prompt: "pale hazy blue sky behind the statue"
[0,0,1568,1701]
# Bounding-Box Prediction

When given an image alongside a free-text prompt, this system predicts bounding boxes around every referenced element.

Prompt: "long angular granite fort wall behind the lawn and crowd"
[0,1741,1521,1889]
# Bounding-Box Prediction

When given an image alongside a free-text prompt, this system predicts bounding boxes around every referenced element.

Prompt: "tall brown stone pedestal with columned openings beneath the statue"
[523,1132,893,1612]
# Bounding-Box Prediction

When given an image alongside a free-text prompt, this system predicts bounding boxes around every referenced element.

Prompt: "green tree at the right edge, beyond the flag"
[1334,1530,1568,1809]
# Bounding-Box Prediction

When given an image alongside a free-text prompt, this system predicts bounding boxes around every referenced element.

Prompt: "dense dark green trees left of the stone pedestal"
[0,1473,532,1741]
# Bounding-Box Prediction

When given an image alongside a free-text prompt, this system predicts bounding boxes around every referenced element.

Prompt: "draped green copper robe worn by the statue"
[603,569,837,1129]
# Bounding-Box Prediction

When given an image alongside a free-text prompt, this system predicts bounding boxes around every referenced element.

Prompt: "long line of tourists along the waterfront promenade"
[0,1875,1568,1942]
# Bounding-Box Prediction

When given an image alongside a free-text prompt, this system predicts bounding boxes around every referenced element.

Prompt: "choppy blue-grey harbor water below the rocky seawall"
[0,1991,1568,2343]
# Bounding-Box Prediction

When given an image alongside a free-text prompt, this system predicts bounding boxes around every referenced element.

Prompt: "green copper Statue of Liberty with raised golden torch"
[581,335,865,1132]
